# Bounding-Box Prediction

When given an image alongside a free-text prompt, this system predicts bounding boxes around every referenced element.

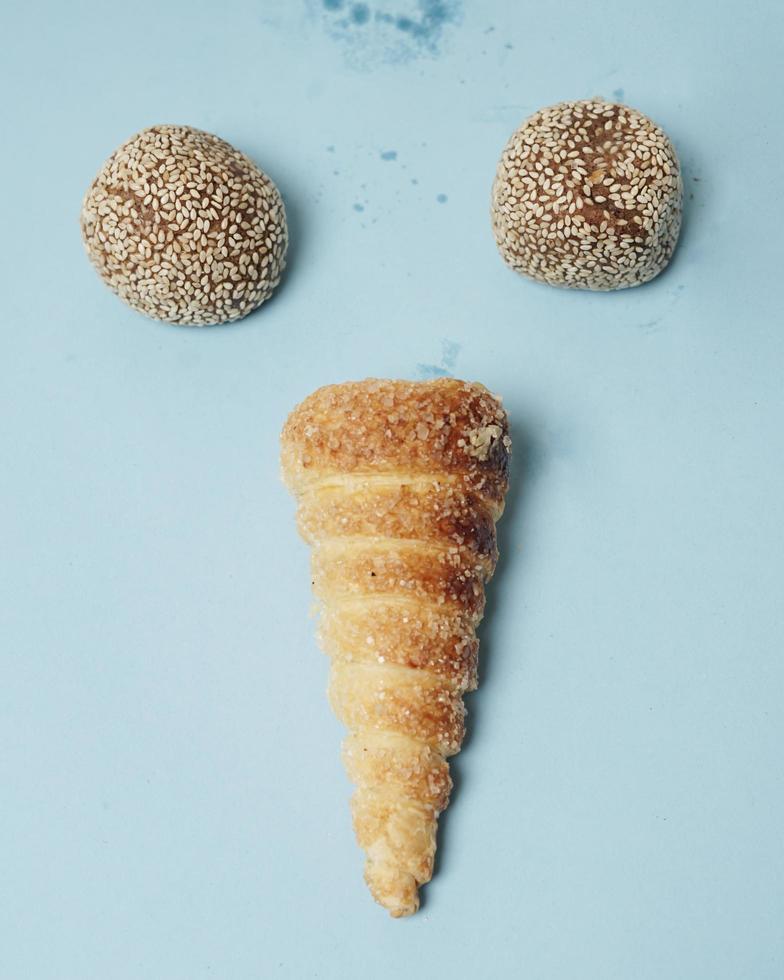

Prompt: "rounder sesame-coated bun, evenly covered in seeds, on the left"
[81,126,288,326]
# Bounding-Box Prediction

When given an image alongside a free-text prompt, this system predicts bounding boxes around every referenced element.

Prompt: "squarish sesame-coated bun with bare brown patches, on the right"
[491,99,683,290]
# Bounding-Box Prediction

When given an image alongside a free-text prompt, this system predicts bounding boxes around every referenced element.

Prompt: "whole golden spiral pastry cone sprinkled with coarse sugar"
[282,378,510,917]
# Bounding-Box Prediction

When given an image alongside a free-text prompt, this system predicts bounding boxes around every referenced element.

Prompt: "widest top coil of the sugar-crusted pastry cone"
[281,378,510,506]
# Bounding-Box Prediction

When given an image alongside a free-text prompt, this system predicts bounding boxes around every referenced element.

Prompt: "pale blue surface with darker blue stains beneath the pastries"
[0,0,784,980]
